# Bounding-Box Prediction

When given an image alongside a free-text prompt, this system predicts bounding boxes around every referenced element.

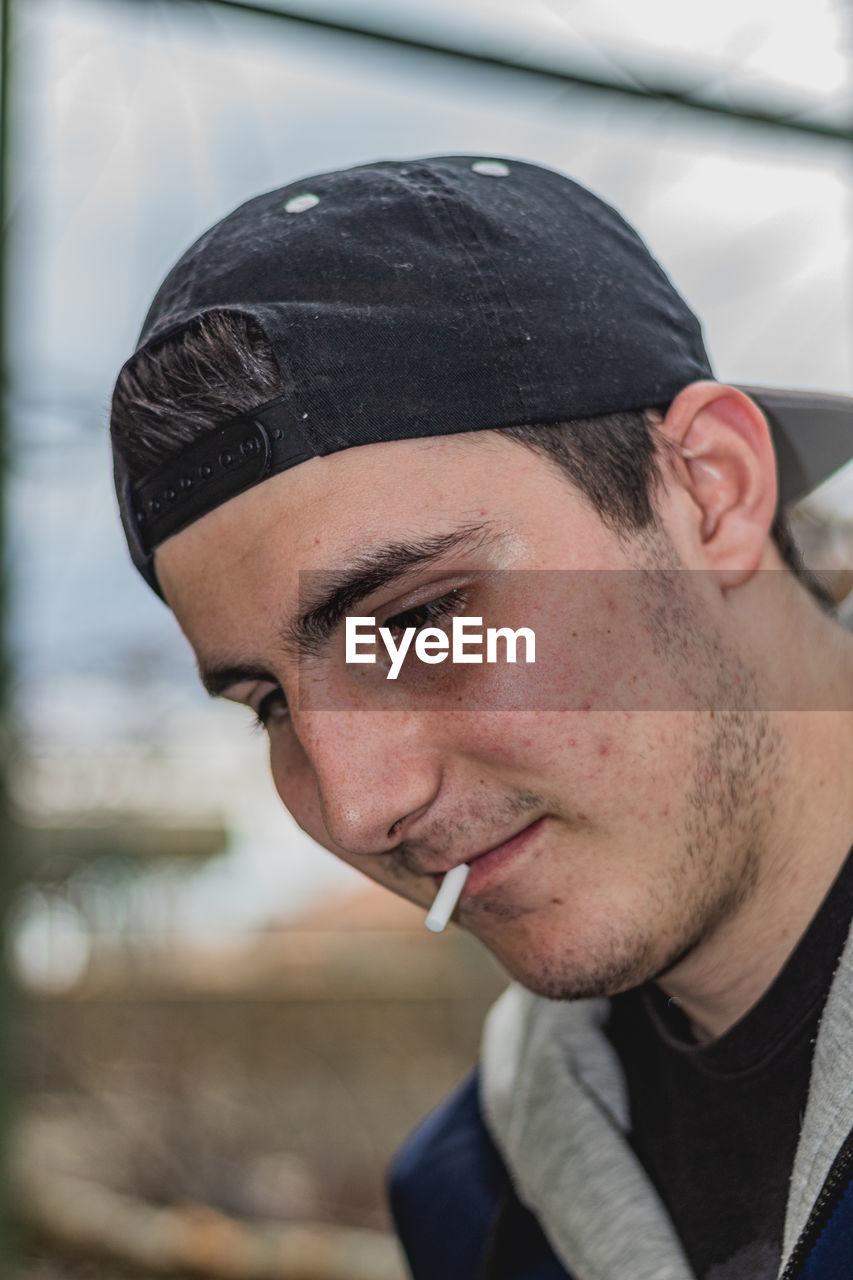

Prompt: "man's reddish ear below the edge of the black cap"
[660,381,777,586]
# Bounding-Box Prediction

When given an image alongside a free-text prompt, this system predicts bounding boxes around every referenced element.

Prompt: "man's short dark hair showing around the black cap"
[111,311,833,605]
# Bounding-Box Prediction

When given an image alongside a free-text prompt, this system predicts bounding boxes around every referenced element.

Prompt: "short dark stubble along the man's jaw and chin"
[481,567,783,1000]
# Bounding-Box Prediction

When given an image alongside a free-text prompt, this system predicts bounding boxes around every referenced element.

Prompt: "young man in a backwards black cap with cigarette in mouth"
[113,156,853,1280]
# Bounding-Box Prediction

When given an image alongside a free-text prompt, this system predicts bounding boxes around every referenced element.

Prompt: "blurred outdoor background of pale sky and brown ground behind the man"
[0,0,853,1280]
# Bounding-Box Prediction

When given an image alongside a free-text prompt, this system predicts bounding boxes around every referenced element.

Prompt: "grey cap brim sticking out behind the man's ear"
[738,383,853,507]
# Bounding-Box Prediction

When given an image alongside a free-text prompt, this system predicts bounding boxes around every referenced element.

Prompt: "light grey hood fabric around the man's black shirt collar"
[473,916,853,1280]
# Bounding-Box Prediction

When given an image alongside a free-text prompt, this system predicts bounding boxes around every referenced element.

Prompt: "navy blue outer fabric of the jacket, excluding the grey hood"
[389,1071,853,1280]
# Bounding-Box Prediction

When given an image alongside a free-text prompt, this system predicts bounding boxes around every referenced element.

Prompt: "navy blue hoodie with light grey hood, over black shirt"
[391,933,853,1280]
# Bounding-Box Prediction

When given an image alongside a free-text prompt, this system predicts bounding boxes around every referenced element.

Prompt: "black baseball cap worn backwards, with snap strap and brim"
[114,156,853,593]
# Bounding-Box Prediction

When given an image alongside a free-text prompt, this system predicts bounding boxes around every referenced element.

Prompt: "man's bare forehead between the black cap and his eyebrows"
[156,433,617,686]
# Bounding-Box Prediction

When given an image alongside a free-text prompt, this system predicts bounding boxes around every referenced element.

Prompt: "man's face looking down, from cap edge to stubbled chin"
[156,431,770,996]
